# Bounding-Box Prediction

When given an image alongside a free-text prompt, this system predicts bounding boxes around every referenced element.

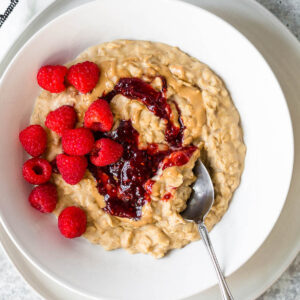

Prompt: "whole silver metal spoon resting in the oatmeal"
[181,161,233,300]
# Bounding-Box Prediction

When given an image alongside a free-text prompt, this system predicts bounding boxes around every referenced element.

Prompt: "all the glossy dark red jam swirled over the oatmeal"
[89,78,197,220]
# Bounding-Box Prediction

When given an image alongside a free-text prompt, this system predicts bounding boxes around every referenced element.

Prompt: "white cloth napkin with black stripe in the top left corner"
[0,0,55,61]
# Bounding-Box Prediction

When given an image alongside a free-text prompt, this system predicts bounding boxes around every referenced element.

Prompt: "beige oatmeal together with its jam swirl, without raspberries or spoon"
[31,40,246,257]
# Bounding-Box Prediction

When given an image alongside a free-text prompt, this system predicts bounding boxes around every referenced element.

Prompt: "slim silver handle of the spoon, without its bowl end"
[198,222,234,300]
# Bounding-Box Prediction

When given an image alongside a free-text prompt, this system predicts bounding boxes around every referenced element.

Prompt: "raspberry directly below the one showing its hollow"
[29,183,57,213]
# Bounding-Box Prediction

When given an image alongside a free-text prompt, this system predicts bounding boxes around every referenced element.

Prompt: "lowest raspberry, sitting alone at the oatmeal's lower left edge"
[58,206,86,239]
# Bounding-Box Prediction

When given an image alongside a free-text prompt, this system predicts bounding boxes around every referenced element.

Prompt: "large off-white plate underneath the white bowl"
[0,0,300,299]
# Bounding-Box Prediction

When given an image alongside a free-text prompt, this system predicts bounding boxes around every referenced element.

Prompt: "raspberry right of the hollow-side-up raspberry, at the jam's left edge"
[56,154,87,184]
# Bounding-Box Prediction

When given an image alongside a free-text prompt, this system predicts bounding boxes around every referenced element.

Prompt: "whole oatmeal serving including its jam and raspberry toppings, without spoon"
[25,40,246,258]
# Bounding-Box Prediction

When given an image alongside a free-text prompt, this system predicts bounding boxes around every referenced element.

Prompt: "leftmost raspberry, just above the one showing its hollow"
[19,125,47,157]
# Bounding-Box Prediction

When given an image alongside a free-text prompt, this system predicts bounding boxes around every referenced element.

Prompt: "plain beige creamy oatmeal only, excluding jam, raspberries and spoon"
[31,40,246,257]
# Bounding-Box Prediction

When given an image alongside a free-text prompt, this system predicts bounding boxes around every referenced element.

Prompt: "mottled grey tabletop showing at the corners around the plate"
[0,0,300,300]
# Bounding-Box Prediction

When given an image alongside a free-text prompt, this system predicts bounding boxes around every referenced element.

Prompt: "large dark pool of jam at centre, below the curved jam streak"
[89,121,170,219]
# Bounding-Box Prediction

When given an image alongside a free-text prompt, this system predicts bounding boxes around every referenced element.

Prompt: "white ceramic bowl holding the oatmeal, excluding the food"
[0,0,293,300]
